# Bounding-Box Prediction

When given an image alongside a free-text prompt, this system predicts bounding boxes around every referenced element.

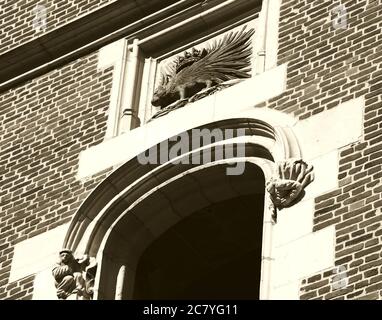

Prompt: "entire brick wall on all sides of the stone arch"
[0,0,382,299]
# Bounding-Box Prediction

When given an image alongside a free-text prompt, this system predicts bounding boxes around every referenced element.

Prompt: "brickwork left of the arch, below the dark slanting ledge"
[0,53,113,299]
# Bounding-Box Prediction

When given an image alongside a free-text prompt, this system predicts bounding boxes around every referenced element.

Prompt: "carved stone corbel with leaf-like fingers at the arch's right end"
[266,159,314,222]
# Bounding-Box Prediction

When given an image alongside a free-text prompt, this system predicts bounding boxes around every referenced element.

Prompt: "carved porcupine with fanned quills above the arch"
[151,27,255,108]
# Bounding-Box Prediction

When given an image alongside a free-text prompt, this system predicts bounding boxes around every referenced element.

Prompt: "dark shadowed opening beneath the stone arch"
[131,163,264,299]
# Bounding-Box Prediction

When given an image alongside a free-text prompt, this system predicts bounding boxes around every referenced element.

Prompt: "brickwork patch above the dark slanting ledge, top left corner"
[0,0,116,54]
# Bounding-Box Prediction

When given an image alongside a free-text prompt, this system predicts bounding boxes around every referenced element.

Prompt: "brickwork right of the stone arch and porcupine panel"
[267,0,382,299]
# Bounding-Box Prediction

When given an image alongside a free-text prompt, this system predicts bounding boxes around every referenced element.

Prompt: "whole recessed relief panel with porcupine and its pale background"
[151,25,255,119]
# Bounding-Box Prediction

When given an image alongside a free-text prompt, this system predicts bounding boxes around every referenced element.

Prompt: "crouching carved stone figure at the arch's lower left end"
[52,249,96,300]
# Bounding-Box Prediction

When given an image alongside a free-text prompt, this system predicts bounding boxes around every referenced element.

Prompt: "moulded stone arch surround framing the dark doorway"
[64,118,299,299]
